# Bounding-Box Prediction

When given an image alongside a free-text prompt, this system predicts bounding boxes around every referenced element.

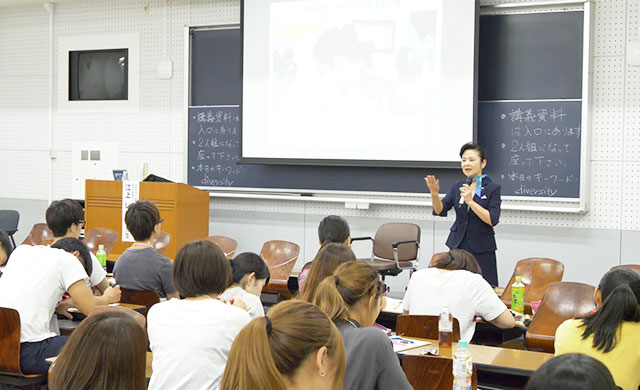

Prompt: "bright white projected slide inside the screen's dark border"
[242,0,475,165]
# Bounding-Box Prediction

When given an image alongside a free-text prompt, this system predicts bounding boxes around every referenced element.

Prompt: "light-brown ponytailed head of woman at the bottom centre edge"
[220,300,345,390]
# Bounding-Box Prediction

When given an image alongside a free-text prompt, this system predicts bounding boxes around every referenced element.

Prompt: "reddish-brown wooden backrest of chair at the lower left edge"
[0,307,22,375]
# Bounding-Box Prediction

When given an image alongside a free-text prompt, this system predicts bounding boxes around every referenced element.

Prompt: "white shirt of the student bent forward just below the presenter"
[403,268,507,341]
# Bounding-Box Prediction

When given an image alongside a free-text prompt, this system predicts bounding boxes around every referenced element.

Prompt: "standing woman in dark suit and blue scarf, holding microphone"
[424,143,502,286]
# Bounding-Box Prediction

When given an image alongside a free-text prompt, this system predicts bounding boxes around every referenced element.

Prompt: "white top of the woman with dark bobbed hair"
[147,298,250,390]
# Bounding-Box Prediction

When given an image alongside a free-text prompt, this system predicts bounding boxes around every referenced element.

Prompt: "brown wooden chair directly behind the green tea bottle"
[500,257,564,314]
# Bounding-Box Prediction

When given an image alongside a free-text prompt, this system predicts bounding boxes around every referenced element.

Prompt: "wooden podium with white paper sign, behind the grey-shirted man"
[84,180,209,261]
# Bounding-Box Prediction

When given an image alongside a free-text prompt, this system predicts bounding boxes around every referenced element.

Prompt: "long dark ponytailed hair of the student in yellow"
[582,269,640,353]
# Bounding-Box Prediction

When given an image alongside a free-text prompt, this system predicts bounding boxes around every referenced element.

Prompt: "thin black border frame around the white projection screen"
[238,0,480,169]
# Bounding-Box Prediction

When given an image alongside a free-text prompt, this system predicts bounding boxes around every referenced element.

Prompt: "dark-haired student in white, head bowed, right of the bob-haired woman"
[220,252,271,318]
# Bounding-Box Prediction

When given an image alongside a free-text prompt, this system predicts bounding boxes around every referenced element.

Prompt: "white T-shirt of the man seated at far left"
[0,245,87,343]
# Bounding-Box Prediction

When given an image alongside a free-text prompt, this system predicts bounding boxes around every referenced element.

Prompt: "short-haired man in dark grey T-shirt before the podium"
[113,200,179,299]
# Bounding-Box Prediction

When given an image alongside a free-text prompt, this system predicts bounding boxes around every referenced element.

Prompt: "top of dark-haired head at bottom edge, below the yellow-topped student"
[525,353,618,390]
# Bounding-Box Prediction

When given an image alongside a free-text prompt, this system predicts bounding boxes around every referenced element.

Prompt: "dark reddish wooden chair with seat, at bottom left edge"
[0,307,46,389]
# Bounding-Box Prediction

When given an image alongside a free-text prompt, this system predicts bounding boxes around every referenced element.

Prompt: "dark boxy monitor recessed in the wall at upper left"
[69,48,129,101]
